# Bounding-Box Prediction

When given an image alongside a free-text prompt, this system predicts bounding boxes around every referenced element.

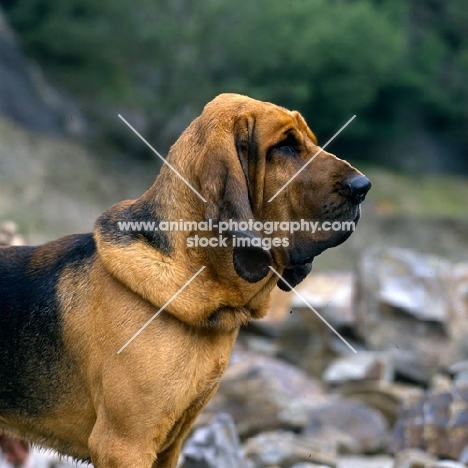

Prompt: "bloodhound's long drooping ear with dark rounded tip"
[200,116,271,283]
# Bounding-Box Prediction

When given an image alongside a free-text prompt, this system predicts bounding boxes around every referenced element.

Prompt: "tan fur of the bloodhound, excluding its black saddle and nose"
[0,94,368,468]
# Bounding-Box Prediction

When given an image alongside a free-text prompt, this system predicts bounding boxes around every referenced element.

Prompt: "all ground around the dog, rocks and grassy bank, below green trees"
[0,5,468,468]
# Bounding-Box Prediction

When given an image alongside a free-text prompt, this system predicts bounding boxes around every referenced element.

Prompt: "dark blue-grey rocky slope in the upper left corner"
[0,9,86,135]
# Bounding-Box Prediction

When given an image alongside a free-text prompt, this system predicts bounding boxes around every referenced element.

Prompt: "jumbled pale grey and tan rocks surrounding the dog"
[0,222,468,468]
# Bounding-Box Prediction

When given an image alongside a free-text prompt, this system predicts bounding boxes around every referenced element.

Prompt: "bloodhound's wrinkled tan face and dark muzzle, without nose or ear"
[245,106,362,268]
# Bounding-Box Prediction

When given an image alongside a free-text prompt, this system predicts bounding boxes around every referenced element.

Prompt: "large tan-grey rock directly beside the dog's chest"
[197,351,325,439]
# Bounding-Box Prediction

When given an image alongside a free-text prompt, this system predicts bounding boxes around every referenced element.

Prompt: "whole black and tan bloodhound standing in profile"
[0,94,370,468]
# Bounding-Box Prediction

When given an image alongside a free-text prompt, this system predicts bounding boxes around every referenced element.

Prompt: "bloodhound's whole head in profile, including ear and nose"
[168,94,370,290]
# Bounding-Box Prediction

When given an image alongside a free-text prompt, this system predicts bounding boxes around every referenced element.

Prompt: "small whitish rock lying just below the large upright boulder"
[322,351,393,385]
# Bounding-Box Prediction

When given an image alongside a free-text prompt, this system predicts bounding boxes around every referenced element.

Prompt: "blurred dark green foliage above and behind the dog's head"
[0,0,468,171]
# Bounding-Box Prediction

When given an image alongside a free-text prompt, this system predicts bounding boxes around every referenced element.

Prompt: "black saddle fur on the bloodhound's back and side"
[0,234,95,424]
